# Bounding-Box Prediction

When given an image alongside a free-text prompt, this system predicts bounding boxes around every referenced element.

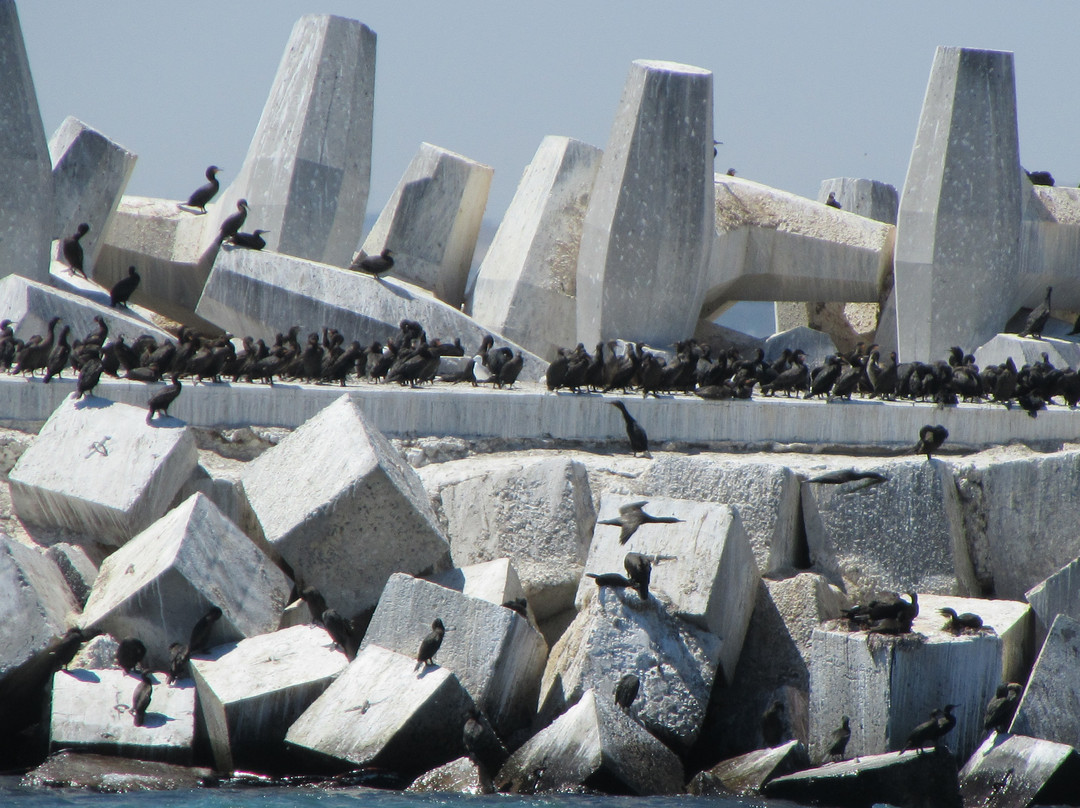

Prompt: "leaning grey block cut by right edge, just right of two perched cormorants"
[1009,615,1080,748]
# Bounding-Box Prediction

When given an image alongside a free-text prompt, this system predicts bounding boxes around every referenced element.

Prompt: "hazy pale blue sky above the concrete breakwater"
[18,0,1080,221]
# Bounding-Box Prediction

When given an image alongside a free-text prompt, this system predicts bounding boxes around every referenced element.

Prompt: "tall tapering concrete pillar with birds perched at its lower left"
[213,14,376,267]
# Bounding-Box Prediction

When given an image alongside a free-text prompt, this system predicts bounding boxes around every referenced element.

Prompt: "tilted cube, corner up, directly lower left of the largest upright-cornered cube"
[80,494,292,670]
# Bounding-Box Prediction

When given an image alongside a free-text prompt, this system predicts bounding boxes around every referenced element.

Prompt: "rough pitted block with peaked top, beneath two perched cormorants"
[539,587,721,750]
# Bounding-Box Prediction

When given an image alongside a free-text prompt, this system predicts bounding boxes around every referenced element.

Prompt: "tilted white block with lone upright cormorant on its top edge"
[285,645,473,777]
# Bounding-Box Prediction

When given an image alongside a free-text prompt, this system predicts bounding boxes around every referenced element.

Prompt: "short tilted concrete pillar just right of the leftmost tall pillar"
[49,116,137,277]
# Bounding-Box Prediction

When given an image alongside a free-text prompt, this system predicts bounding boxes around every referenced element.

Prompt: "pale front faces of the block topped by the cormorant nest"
[810,623,1002,760]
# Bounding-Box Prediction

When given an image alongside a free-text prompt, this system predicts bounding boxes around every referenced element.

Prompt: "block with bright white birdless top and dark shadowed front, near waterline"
[191,625,349,771]
